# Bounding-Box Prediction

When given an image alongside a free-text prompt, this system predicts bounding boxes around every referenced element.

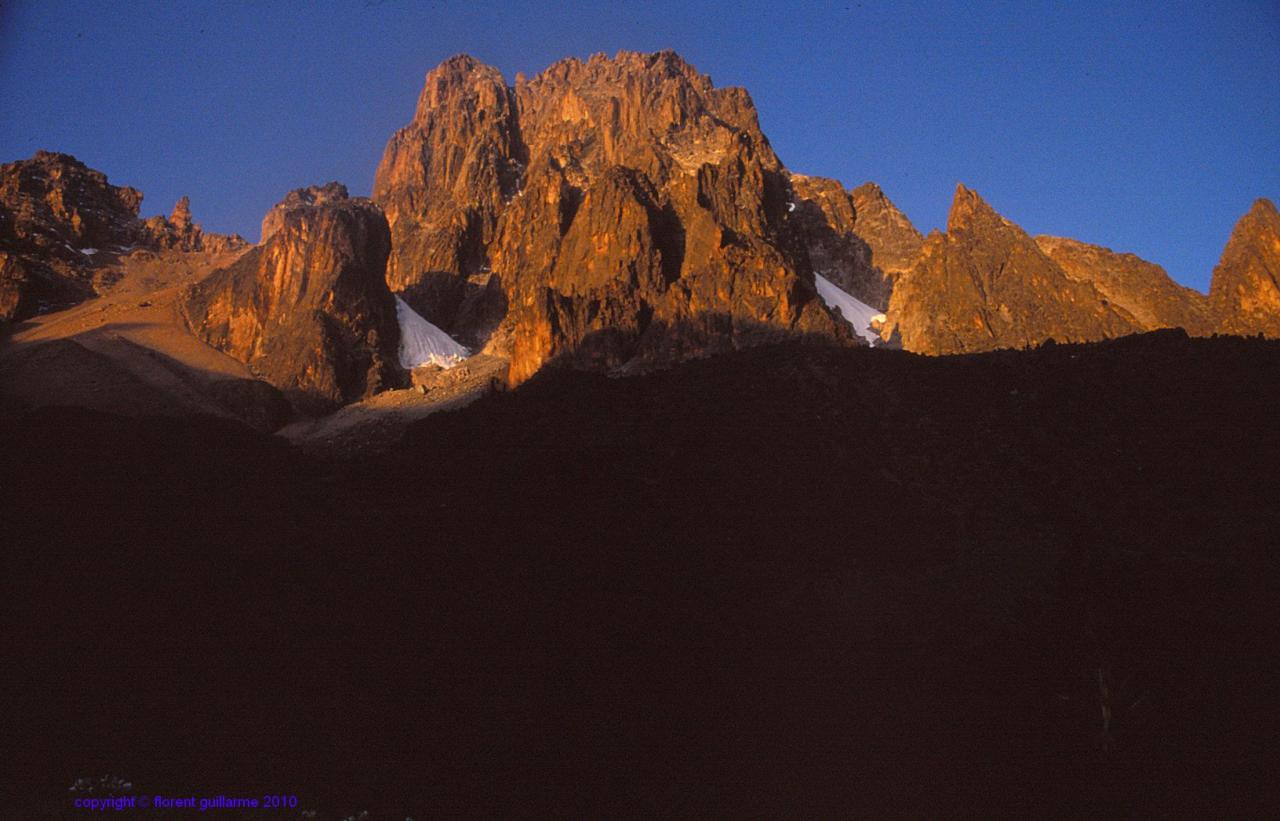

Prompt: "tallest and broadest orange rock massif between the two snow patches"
[374,51,851,382]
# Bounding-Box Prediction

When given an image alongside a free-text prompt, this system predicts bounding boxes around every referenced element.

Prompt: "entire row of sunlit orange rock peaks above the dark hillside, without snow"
[0,51,1280,419]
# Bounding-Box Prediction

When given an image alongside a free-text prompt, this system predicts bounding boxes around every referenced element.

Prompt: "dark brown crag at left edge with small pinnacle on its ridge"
[0,151,243,321]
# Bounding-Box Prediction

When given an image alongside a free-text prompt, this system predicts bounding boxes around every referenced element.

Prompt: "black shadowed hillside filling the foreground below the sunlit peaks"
[0,332,1280,818]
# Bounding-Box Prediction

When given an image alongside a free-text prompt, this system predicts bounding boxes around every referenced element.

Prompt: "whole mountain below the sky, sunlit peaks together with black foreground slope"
[0,51,1280,821]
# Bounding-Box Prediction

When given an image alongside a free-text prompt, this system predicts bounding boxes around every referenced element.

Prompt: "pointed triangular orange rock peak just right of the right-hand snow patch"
[884,186,1142,354]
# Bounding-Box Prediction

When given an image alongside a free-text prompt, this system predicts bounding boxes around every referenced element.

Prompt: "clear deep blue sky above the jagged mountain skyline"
[0,0,1280,289]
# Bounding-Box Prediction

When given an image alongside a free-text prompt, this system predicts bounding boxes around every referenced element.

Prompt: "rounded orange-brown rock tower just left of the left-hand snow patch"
[183,183,404,412]
